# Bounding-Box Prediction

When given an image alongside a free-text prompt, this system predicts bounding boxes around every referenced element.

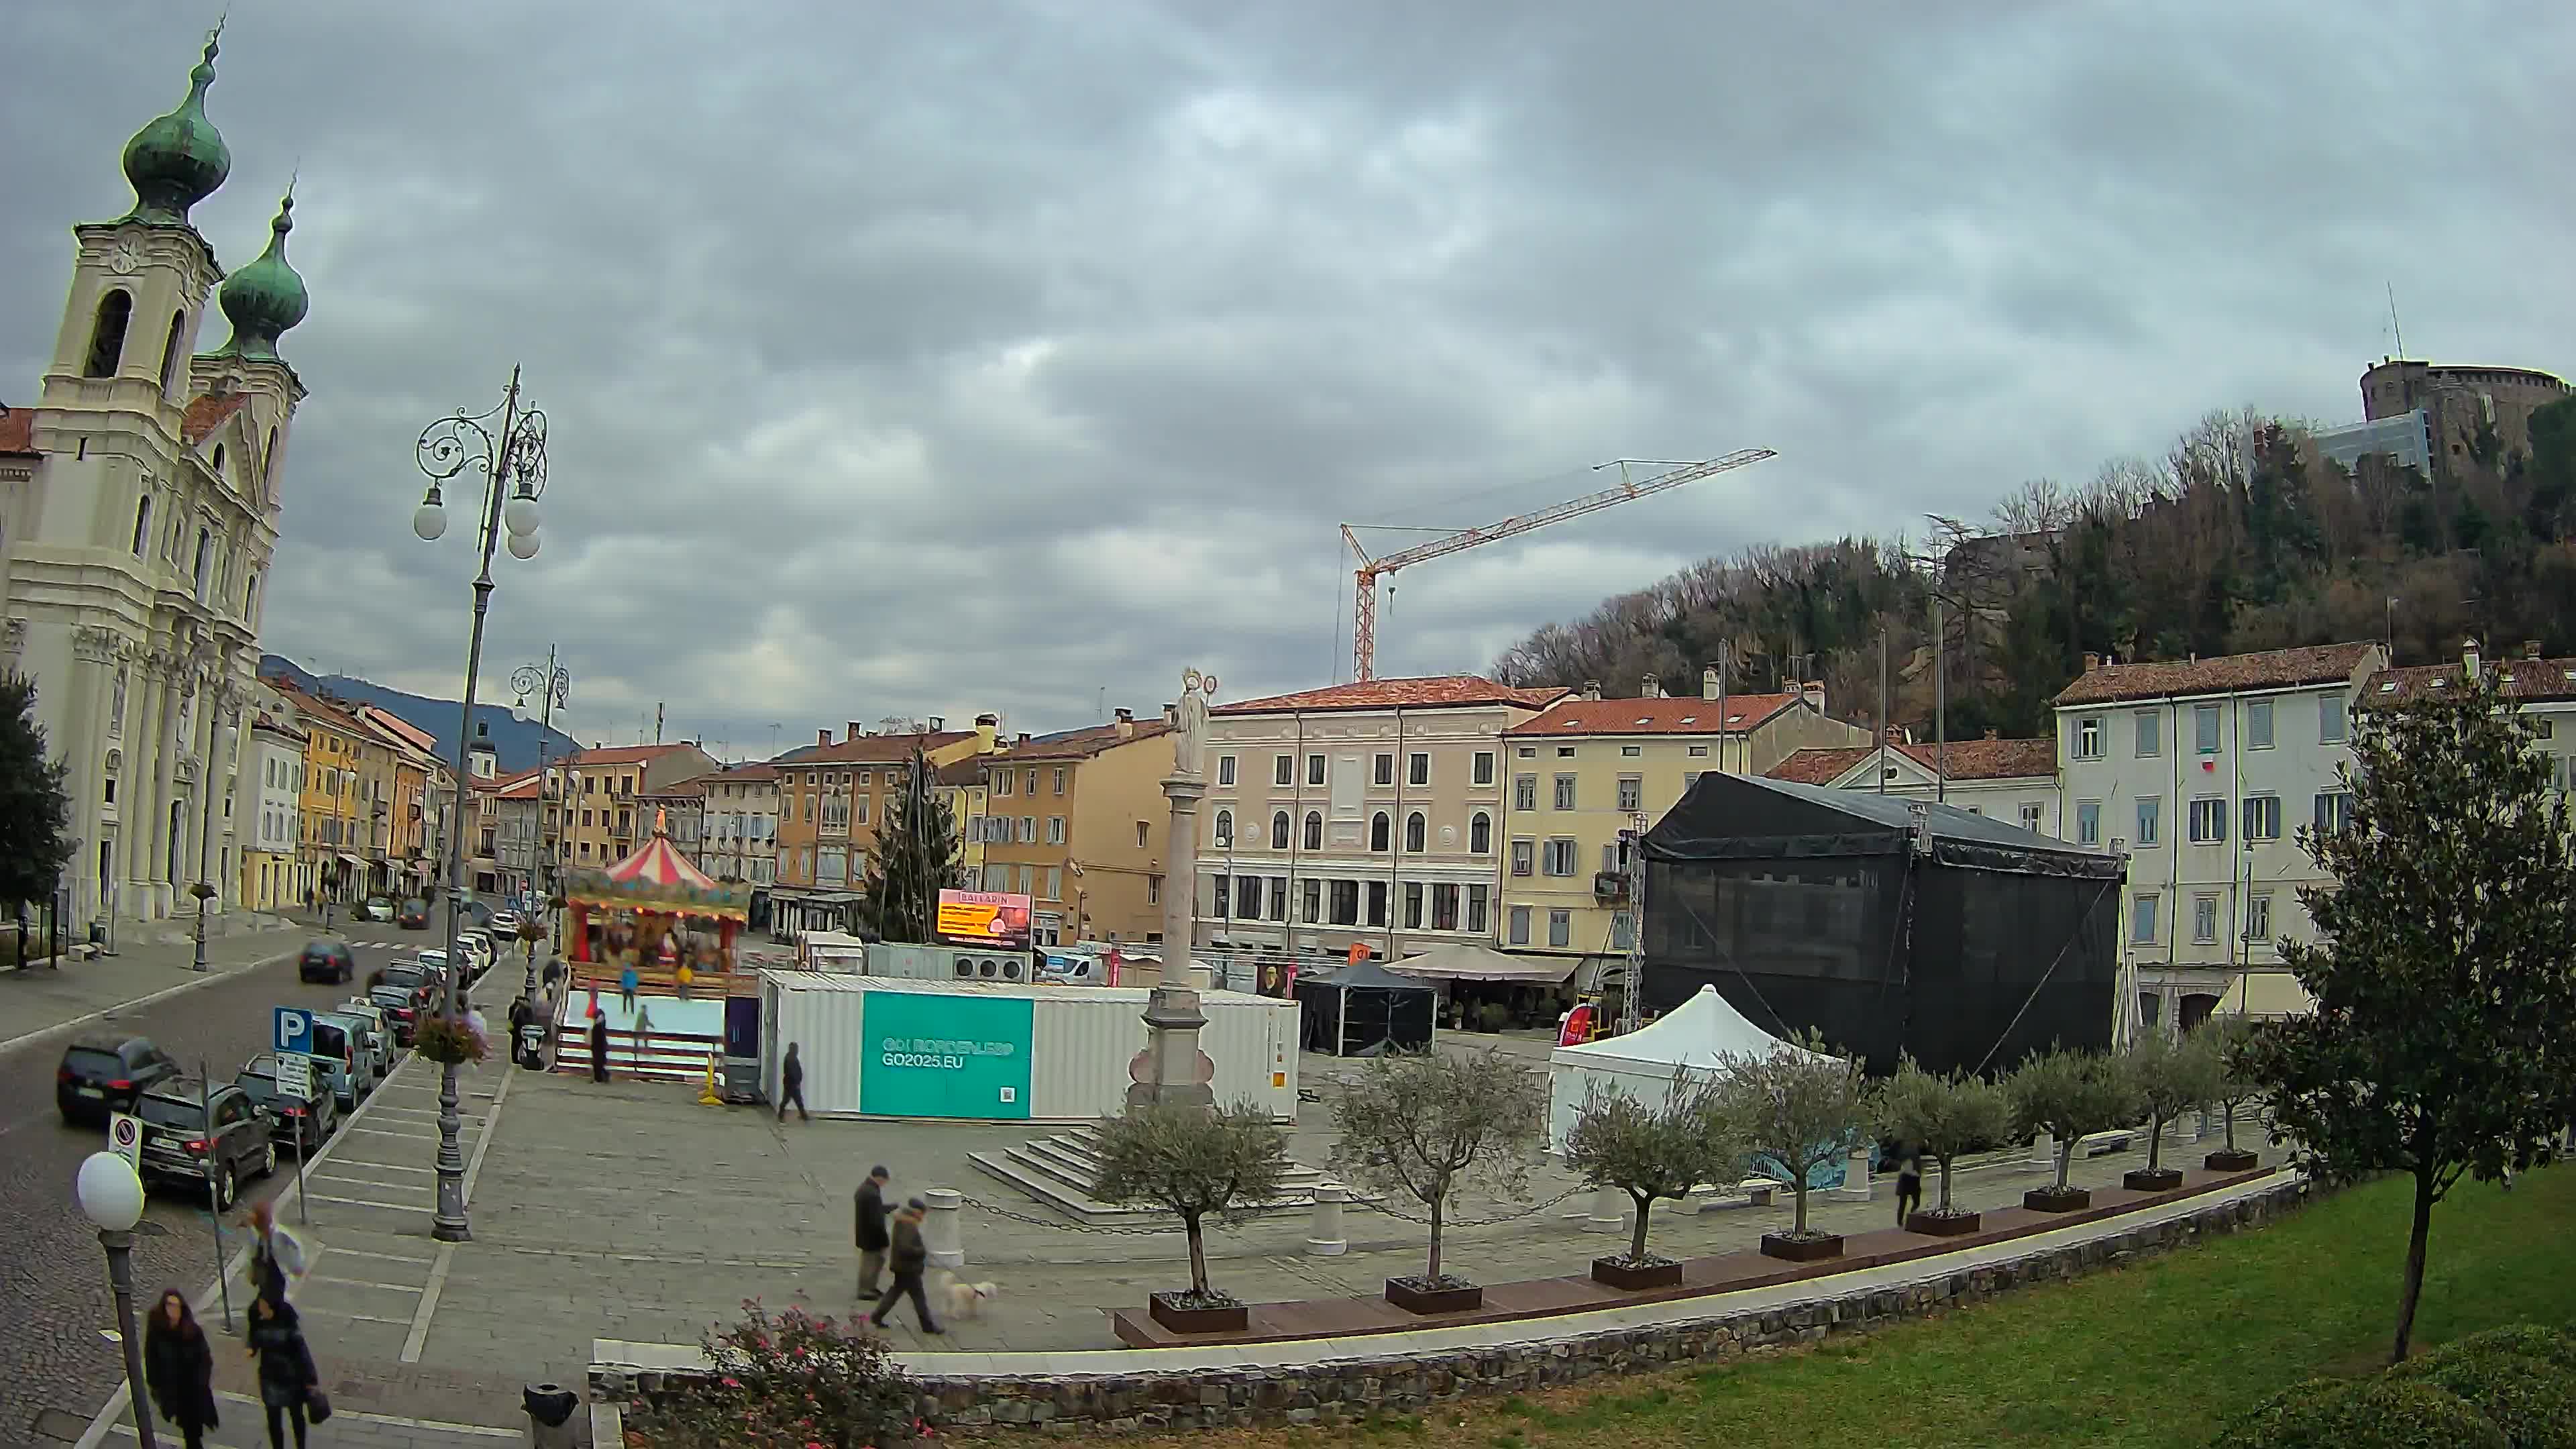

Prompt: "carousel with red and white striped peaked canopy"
[564,810,752,985]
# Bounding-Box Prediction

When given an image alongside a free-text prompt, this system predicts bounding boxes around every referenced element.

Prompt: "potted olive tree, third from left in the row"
[1566,1067,1744,1292]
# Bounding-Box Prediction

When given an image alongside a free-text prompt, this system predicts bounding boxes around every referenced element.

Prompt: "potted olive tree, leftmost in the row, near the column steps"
[1092,1101,1288,1333]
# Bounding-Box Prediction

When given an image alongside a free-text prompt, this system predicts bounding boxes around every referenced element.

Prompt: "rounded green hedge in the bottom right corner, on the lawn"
[2215,1323,2576,1449]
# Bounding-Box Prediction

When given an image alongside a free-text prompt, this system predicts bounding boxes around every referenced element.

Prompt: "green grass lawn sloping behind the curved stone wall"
[1190,1168,2576,1449]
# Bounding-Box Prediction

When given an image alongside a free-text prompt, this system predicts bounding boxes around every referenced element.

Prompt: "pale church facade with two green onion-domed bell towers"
[0,39,307,920]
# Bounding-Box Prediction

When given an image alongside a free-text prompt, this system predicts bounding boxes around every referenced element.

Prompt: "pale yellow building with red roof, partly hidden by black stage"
[1497,670,1870,969]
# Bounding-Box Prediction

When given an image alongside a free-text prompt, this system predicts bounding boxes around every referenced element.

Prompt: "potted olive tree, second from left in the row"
[1332,1049,1548,1312]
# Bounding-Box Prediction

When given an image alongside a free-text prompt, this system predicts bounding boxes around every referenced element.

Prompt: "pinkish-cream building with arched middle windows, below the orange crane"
[1193,676,1566,959]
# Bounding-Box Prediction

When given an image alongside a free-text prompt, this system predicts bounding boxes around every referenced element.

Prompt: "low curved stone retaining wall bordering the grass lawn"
[590,1181,2308,1434]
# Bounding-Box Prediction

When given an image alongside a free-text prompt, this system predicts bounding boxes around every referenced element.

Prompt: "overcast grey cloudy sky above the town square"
[0,0,2576,755]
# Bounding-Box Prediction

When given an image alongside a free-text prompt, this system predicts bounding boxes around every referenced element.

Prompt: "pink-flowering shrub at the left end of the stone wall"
[629,1299,925,1449]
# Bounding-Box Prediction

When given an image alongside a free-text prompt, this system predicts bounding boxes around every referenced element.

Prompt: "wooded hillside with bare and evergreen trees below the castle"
[1494,397,2576,737]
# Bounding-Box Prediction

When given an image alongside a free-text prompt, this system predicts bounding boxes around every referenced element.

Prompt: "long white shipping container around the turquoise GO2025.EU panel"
[760,972,1298,1122]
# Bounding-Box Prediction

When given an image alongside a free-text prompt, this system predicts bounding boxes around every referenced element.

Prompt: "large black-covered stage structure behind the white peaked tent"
[1644,773,2123,1073]
